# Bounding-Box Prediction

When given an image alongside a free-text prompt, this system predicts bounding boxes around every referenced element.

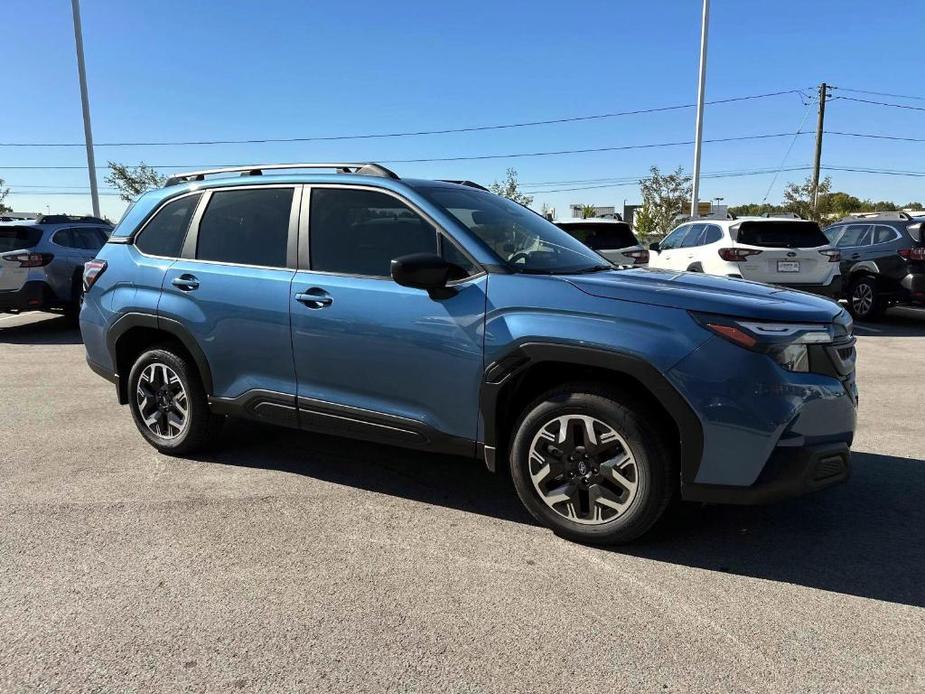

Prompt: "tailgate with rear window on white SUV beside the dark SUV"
[736,219,838,285]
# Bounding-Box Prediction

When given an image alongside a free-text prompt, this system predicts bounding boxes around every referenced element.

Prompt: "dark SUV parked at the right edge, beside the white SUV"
[825,212,925,320]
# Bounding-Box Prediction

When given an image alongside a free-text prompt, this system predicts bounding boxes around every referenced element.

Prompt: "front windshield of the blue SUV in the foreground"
[417,186,612,274]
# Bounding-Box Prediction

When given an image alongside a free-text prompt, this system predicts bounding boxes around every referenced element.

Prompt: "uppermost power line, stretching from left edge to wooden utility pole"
[0,89,804,147]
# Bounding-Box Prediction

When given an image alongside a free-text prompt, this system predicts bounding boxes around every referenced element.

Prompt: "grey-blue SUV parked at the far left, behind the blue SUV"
[0,214,112,316]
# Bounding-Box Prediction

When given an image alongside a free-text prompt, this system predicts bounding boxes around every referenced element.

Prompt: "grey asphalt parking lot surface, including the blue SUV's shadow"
[0,309,925,692]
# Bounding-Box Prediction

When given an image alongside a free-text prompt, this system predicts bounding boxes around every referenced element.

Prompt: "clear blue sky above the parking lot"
[0,0,925,216]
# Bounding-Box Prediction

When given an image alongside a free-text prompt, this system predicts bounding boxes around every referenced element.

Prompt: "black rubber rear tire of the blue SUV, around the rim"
[128,345,224,455]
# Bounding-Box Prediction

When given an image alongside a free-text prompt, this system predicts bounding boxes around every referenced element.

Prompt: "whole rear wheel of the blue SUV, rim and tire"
[128,346,223,455]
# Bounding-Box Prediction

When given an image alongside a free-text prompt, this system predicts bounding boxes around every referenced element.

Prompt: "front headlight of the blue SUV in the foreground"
[691,312,834,373]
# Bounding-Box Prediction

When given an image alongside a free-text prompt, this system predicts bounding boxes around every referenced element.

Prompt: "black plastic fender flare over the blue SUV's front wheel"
[479,342,703,483]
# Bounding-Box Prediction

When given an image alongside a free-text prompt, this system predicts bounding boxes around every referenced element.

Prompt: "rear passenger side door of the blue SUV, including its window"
[158,185,301,402]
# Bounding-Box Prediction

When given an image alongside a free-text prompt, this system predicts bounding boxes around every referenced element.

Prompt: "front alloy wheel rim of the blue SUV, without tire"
[529,414,639,525]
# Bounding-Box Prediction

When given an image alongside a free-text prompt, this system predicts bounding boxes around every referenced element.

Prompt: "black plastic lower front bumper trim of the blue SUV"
[681,443,851,504]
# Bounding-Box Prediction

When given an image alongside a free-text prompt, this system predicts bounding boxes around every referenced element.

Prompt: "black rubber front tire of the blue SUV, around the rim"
[510,383,678,545]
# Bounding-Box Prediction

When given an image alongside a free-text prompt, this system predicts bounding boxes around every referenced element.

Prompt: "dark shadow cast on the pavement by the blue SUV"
[200,421,925,607]
